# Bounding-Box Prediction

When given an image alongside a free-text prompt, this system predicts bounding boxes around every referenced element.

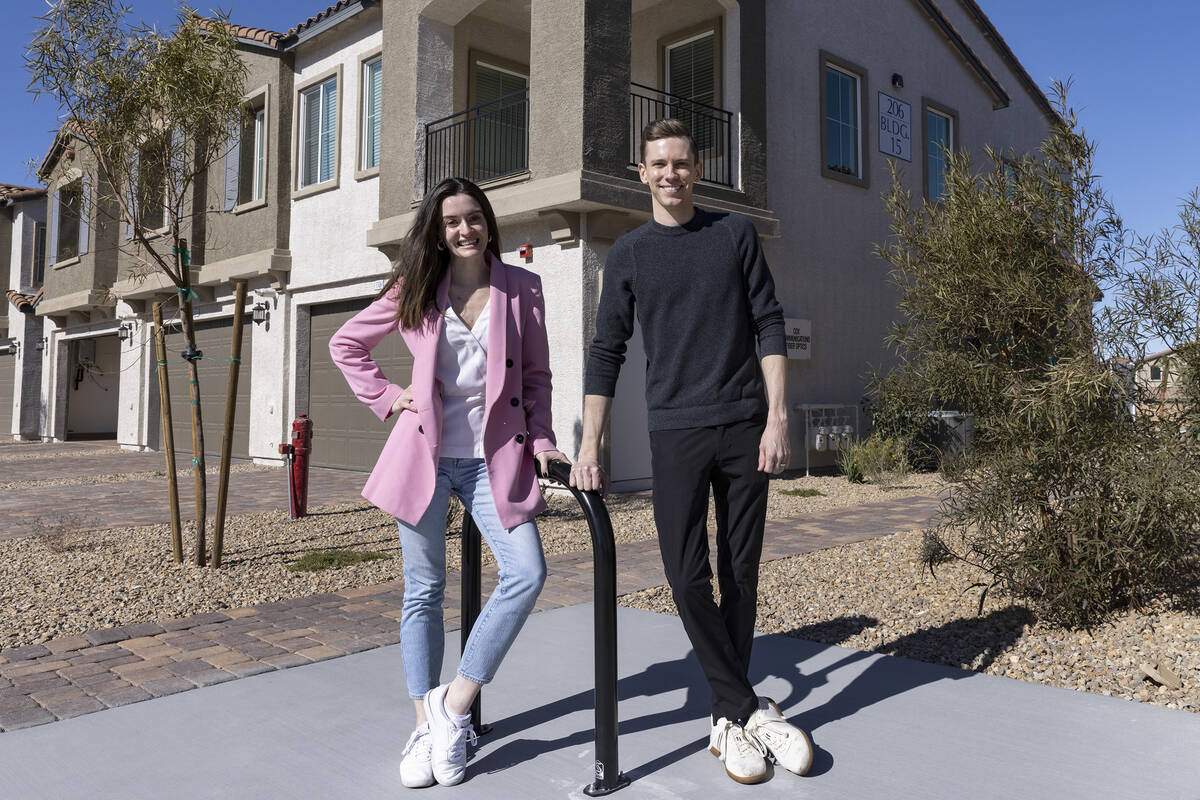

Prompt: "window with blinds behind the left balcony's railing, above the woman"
[470,61,529,180]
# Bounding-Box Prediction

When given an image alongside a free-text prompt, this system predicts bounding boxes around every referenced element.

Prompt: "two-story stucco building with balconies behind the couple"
[14,0,1055,488]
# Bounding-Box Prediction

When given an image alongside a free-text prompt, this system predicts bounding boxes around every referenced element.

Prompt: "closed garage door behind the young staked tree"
[167,319,253,458]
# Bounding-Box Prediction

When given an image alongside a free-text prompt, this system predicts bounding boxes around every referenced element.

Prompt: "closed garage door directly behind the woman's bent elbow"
[308,299,413,470]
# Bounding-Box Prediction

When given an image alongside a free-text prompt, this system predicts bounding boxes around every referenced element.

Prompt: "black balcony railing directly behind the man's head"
[629,83,733,187]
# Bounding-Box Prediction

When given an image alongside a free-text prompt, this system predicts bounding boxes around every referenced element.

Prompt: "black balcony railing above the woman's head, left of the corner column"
[425,89,529,192]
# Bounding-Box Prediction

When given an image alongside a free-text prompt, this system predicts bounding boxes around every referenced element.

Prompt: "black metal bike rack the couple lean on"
[462,462,629,798]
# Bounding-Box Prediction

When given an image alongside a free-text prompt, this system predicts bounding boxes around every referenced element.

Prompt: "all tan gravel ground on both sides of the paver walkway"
[0,465,1200,711]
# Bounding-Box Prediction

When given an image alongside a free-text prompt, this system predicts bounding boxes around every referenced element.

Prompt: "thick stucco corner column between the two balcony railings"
[529,0,631,179]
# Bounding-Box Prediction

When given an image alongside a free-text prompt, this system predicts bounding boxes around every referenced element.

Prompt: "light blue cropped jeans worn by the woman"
[396,458,546,699]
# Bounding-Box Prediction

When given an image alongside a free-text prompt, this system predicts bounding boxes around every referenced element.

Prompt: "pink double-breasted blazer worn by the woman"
[329,253,556,528]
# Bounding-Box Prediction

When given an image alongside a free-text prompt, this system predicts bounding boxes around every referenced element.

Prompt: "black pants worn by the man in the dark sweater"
[650,420,767,722]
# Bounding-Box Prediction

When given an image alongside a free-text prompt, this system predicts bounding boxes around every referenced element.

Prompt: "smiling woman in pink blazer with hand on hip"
[329,178,565,787]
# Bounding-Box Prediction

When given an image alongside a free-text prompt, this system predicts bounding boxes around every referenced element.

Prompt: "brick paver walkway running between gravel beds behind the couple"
[0,487,937,730]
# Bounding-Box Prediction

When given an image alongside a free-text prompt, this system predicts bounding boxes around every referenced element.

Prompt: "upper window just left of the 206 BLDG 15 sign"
[821,52,868,187]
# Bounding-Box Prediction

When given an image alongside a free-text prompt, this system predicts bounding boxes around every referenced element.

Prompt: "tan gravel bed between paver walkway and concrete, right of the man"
[620,530,1200,711]
